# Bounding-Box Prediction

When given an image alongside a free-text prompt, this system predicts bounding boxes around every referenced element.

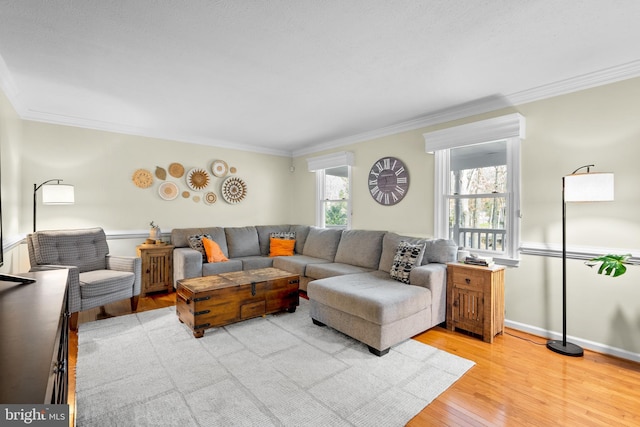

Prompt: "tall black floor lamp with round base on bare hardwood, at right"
[547,165,613,357]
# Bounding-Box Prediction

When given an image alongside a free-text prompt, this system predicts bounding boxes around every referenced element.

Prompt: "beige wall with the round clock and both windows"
[295,79,640,360]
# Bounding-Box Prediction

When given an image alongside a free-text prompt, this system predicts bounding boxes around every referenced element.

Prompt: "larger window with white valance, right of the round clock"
[424,114,524,265]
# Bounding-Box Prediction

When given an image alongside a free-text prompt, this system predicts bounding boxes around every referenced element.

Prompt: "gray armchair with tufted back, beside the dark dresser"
[27,228,142,330]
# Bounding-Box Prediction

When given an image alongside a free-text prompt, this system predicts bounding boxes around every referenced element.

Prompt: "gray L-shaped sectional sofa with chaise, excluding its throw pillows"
[171,225,457,356]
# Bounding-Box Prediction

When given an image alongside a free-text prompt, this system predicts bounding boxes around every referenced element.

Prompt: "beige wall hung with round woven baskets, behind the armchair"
[21,122,292,236]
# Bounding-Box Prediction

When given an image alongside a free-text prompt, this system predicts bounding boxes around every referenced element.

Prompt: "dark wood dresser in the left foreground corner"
[0,269,69,404]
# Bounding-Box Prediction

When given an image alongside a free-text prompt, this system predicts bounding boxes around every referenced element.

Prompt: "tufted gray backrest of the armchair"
[32,228,109,273]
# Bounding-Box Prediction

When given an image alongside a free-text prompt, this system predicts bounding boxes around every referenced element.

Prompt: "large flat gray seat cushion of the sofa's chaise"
[307,270,431,325]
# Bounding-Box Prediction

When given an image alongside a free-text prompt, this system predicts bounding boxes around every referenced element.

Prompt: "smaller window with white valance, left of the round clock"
[307,152,353,229]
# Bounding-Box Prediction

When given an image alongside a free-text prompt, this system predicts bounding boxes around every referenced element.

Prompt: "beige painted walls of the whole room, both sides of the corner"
[0,79,640,358]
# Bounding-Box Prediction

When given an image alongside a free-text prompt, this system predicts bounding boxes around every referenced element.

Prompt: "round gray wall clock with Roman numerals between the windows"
[368,157,409,206]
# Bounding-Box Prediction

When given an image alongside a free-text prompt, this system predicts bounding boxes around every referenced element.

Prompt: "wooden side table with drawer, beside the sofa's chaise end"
[447,262,505,343]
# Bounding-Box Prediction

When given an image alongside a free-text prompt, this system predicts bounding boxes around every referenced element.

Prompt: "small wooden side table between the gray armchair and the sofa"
[136,244,174,295]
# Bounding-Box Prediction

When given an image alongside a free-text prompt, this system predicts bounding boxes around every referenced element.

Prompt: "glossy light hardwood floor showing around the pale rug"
[69,293,640,427]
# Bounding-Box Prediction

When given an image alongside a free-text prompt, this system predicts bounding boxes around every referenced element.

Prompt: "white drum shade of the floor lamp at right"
[564,172,613,202]
